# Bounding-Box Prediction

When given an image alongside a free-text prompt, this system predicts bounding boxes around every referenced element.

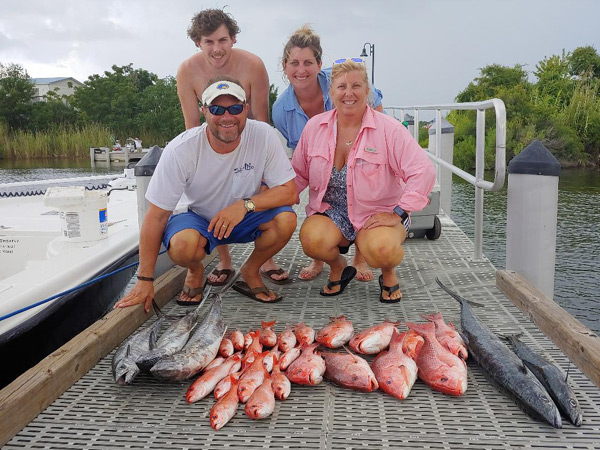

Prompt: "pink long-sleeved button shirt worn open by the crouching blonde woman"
[292,107,435,230]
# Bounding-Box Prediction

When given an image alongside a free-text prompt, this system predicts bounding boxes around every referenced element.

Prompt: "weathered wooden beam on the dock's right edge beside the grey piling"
[496,270,600,387]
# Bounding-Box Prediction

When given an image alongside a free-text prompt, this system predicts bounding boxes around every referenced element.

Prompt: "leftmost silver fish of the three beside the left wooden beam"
[112,316,165,384]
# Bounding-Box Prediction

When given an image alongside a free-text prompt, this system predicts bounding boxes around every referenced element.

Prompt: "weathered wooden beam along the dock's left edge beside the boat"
[0,266,190,447]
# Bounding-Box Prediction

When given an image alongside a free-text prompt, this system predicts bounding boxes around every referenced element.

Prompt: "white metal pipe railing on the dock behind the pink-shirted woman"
[385,98,506,260]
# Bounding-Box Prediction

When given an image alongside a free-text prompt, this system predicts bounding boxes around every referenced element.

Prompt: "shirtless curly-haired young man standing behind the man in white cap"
[177,9,289,300]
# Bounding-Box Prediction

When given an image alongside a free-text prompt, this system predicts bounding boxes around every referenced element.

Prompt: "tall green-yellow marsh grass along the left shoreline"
[0,124,111,159]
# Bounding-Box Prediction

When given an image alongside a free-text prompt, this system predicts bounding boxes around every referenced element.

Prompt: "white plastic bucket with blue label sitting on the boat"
[44,186,108,242]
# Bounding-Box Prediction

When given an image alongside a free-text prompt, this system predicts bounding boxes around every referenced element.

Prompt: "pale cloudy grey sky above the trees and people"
[0,0,600,106]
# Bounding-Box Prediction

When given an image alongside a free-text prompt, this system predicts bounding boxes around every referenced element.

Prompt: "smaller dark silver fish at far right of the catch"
[505,334,582,427]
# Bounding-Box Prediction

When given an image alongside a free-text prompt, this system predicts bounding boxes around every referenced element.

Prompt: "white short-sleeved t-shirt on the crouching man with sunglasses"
[146,120,296,220]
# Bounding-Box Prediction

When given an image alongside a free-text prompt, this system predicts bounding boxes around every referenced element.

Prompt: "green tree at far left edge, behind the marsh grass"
[0,63,35,131]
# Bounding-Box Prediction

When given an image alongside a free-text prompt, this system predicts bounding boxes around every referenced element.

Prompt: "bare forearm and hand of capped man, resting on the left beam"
[115,203,171,312]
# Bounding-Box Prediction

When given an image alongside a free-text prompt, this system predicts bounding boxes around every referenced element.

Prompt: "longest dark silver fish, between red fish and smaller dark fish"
[435,277,562,428]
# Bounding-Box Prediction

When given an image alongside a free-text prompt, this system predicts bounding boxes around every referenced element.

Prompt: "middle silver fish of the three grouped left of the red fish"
[137,309,198,371]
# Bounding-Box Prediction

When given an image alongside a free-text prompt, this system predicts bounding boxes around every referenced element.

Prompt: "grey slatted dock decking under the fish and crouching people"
[0,199,600,450]
